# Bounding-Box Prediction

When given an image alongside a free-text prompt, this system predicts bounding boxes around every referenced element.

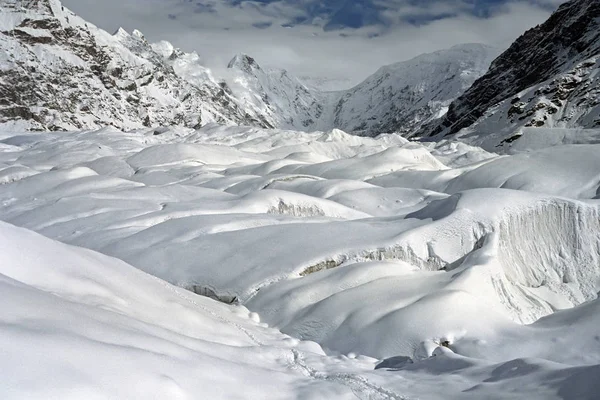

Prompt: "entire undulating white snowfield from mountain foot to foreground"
[0,125,600,399]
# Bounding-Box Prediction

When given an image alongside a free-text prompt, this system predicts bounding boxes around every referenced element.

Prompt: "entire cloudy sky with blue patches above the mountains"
[62,0,564,89]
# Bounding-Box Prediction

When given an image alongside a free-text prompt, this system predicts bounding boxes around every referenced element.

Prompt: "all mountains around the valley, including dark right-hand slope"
[0,0,600,149]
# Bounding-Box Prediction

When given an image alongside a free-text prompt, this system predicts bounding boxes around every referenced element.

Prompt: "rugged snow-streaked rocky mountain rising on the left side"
[0,0,269,130]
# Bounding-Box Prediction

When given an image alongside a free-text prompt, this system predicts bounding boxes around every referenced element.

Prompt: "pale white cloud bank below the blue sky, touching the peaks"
[63,0,561,88]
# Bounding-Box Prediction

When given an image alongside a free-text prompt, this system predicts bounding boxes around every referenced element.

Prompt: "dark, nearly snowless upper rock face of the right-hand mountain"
[417,0,600,136]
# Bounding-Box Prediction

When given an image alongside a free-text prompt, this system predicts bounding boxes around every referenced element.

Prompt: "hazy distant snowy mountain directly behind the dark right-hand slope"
[333,44,498,135]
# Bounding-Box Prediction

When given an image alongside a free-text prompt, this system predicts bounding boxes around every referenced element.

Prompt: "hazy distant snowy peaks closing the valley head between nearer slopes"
[228,44,498,136]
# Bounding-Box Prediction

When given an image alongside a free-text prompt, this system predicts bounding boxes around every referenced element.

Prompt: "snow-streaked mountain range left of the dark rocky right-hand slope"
[0,0,496,136]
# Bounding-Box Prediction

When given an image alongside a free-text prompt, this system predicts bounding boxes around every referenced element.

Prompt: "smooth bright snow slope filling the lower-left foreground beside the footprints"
[0,219,390,399]
